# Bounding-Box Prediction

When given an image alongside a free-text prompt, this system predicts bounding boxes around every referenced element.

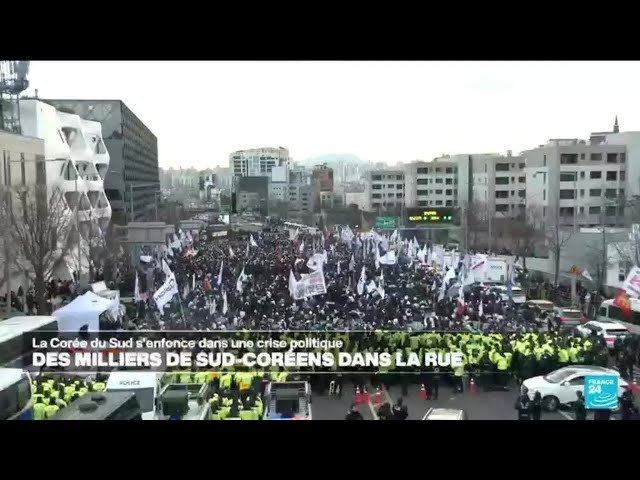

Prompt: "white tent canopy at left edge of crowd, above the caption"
[53,292,117,332]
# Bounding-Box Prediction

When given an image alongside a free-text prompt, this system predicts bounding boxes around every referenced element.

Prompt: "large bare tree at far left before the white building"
[0,186,77,314]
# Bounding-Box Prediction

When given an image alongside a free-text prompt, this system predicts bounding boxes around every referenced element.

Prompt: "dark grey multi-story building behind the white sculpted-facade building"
[45,100,160,223]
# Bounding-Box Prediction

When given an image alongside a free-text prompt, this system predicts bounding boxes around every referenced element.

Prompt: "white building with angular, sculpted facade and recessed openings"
[20,99,111,278]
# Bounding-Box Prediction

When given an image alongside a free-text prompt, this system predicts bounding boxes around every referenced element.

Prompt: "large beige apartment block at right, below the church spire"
[523,138,627,228]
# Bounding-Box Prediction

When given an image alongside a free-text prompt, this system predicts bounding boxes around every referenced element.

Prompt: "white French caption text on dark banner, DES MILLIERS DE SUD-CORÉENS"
[30,331,476,373]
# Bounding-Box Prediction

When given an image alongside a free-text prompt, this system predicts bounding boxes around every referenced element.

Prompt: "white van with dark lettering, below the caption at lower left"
[106,371,164,420]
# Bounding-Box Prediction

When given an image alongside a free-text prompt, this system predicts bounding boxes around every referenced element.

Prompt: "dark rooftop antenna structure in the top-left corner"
[0,60,30,134]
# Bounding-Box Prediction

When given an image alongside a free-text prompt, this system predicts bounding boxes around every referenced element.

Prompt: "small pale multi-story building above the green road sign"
[363,169,406,212]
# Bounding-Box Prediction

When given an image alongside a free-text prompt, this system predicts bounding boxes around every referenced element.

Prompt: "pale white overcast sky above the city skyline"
[25,62,640,168]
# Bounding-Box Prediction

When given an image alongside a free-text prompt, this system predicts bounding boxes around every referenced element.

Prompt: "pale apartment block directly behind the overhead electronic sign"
[404,156,458,207]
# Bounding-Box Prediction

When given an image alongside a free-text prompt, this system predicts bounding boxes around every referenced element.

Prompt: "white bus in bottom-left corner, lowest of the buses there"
[0,368,33,421]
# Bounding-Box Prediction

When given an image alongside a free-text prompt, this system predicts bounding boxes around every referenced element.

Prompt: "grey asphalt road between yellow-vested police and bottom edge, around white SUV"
[312,385,619,420]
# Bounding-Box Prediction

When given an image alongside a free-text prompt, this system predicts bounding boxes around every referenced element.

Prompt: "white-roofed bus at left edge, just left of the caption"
[0,316,58,369]
